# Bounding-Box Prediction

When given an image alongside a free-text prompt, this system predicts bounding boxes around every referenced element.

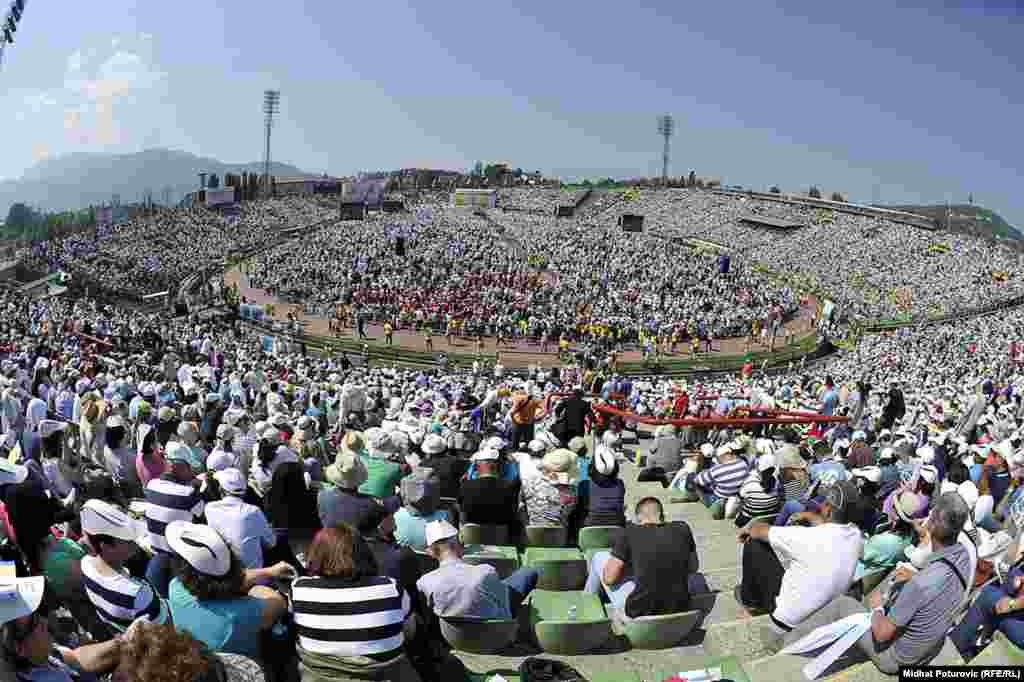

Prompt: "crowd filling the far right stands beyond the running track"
[585,189,1024,321]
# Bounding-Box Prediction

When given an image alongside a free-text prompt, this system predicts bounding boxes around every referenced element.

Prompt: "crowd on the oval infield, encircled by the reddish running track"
[246,196,799,342]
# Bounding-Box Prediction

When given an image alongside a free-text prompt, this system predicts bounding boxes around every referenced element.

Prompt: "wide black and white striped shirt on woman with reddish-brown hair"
[292,576,412,662]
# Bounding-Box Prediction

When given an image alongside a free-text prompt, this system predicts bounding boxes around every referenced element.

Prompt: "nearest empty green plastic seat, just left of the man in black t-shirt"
[528,590,611,654]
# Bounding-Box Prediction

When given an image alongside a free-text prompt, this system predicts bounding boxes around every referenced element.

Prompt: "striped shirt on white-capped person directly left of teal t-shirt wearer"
[82,556,168,632]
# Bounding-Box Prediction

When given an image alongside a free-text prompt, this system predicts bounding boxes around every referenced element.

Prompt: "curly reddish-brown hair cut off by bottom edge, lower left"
[115,623,220,682]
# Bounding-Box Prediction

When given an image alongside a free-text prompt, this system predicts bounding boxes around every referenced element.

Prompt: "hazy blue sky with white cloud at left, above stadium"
[0,0,1024,228]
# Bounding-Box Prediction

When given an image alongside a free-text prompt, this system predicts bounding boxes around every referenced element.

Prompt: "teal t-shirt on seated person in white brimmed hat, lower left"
[168,578,263,658]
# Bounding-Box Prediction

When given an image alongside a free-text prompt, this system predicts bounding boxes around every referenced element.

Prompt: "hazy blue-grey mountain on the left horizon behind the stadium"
[0,150,312,219]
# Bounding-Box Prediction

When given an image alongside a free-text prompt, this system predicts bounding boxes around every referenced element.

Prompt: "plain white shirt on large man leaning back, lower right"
[768,523,864,628]
